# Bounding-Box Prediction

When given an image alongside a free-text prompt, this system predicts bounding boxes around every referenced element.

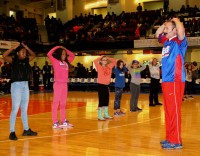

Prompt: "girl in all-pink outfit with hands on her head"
[47,46,75,128]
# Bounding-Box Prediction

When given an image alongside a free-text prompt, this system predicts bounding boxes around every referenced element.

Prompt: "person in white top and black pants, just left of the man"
[149,58,162,106]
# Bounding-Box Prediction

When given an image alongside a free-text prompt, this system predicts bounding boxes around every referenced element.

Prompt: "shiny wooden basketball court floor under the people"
[0,92,200,156]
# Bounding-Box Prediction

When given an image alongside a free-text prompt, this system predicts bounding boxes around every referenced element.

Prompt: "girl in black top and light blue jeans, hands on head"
[3,43,37,140]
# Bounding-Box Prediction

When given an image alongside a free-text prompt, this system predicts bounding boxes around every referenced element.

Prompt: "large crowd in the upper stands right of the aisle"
[45,5,200,43]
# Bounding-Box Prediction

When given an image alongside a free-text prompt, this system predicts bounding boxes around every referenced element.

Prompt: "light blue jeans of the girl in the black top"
[10,81,29,132]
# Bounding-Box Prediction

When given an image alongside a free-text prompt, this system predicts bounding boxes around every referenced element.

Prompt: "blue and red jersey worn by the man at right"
[158,34,188,82]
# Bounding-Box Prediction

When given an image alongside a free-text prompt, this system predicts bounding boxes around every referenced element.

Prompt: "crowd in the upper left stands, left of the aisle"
[0,15,38,43]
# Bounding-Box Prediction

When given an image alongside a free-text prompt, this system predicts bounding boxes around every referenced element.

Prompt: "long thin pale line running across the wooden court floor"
[0,116,161,143]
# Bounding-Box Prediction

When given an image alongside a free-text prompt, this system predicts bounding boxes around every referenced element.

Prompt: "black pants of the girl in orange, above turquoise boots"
[98,84,109,107]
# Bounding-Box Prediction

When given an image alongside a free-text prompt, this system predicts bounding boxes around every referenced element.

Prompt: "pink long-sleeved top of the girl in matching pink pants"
[47,46,75,82]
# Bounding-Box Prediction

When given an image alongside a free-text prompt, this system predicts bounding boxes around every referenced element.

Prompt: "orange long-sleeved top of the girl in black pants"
[94,57,116,85]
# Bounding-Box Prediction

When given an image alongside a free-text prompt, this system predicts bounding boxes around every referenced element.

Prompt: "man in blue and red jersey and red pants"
[156,18,188,149]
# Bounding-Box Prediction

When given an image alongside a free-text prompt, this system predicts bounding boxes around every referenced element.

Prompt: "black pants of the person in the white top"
[149,78,160,104]
